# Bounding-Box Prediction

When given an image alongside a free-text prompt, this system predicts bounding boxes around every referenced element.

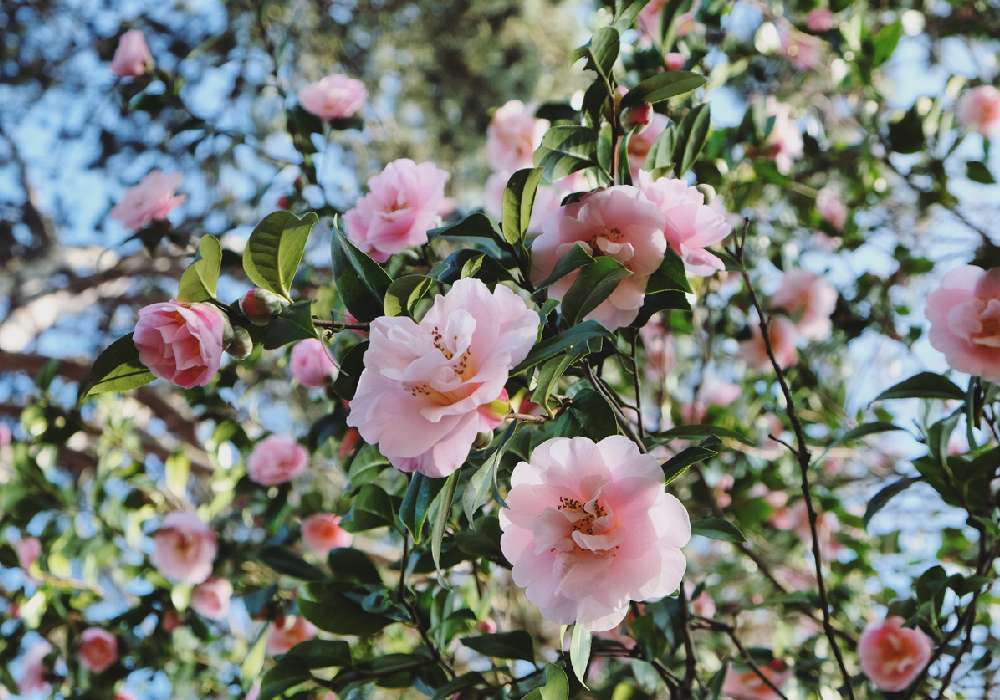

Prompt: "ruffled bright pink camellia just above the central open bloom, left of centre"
[344,158,448,262]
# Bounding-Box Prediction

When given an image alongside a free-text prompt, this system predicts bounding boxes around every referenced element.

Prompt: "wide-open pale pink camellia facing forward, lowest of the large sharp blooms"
[500,435,691,632]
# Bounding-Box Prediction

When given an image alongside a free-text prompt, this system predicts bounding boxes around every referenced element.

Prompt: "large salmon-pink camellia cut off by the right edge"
[927,265,1000,382]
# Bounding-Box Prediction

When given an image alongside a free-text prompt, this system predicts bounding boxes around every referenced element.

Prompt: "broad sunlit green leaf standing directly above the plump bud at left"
[243,211,319,299]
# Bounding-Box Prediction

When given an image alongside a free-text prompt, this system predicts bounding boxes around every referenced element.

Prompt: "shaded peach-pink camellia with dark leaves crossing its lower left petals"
[531,185,666,330]
